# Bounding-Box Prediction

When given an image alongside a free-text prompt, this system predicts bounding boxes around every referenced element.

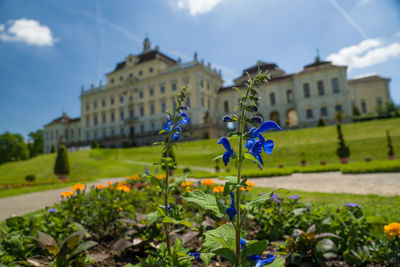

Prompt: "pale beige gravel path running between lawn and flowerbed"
[0,172,400,221]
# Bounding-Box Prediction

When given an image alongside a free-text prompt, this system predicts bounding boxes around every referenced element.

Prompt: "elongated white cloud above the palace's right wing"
[327,39,400,70]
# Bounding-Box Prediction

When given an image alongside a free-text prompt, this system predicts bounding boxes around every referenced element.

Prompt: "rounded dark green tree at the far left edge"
[0,132,29,164]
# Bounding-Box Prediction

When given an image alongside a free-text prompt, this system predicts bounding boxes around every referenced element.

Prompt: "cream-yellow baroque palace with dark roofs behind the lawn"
[44,38,391,153]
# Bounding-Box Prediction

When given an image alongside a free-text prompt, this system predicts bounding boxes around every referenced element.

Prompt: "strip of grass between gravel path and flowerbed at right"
[251,187,400,223]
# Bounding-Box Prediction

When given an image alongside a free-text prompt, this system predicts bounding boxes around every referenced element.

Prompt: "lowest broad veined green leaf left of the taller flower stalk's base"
[202,224,235,252]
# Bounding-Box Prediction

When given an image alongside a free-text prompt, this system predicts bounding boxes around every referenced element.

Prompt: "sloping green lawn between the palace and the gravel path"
[0,119,400,184]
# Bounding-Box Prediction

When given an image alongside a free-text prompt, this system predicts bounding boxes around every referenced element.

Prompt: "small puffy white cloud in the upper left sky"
[0,18,56,46]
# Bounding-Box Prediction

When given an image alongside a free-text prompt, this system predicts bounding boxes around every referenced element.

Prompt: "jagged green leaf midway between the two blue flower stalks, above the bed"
[182,191,228,218]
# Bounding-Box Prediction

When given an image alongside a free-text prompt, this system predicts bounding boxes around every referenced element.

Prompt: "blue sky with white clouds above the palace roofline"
[0,0,400,136]
